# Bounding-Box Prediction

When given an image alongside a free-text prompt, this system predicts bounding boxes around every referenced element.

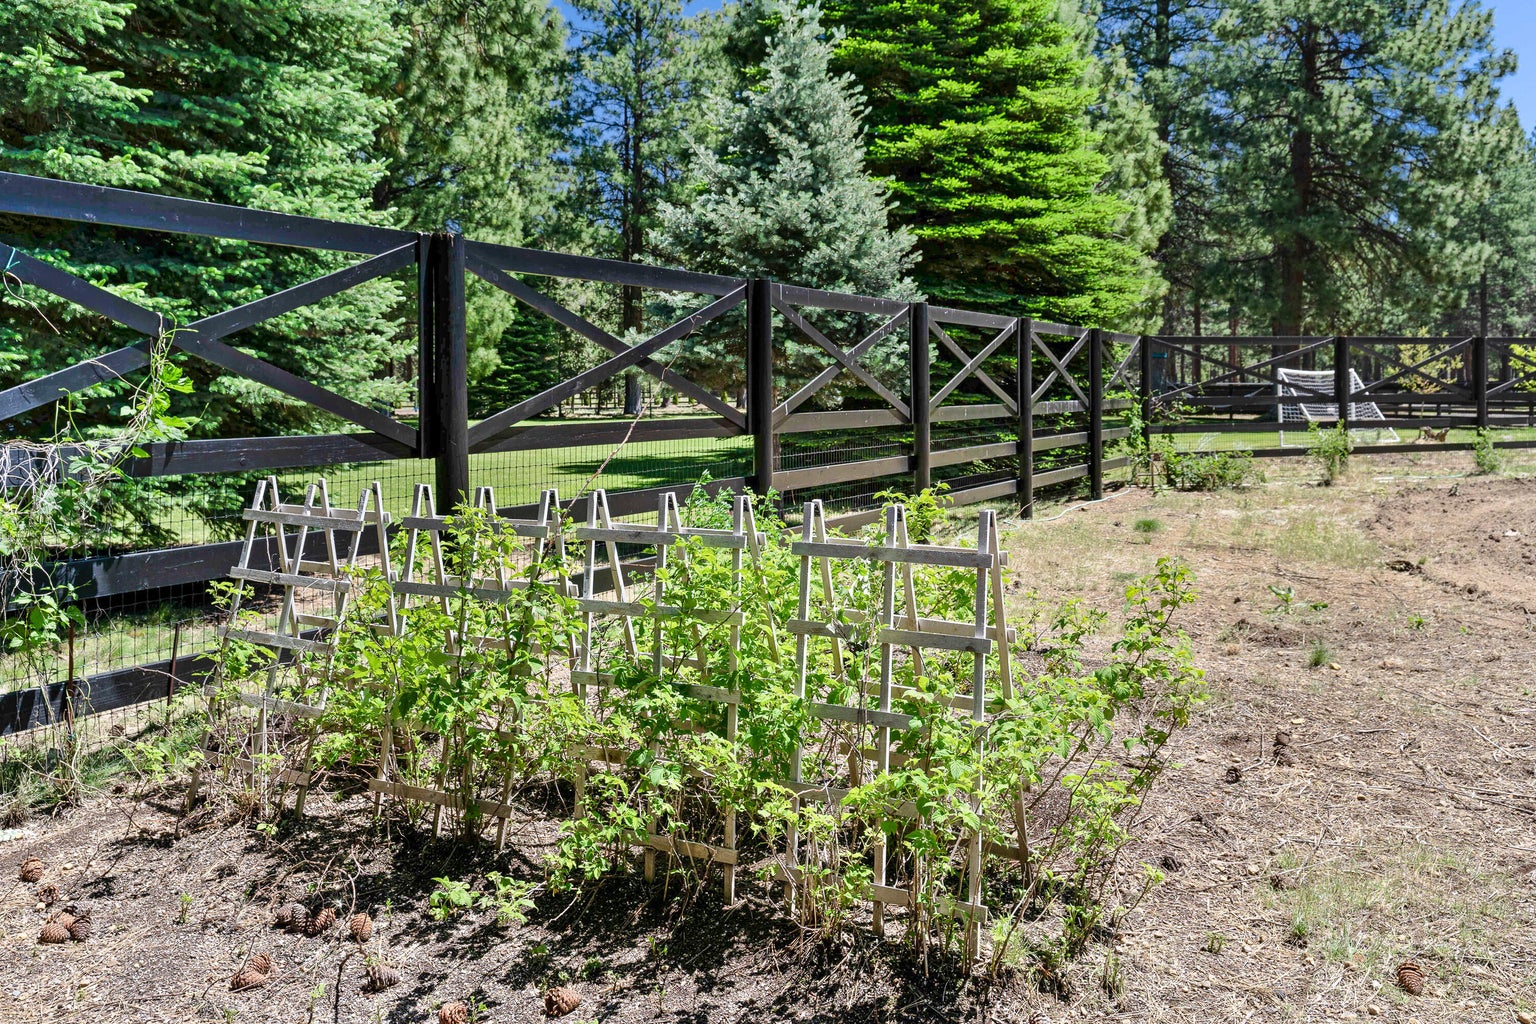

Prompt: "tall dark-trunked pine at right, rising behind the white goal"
[1201,0,1513,335]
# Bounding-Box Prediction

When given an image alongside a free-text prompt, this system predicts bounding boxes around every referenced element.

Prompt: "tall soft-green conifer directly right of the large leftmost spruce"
[373,0,565,385]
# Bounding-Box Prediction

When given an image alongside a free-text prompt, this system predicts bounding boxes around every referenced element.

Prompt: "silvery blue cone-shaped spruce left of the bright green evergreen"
[656,0,915,396]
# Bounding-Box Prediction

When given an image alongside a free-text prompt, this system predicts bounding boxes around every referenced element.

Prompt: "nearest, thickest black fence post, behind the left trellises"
[432,232,470,511]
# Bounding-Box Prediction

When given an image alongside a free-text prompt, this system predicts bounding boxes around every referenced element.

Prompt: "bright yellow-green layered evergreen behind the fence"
[826,0,1149,324]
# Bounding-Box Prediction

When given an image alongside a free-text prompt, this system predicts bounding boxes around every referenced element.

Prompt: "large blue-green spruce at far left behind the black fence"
[0,0,410,433]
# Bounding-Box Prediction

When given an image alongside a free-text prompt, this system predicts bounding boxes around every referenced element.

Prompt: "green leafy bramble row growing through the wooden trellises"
[216,490,1204,964]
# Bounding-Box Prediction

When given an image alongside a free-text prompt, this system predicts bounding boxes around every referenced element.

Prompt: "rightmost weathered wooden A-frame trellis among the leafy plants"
[776,500,1012,952]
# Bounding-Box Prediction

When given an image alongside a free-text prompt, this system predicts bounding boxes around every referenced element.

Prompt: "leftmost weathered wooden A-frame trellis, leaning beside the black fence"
[187,476,393,814]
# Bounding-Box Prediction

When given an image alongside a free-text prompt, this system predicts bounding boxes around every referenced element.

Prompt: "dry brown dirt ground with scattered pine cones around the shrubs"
[0,454,1536,1024]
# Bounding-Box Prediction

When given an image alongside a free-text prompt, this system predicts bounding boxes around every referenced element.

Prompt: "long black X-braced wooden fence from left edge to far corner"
[0,173,1146,734]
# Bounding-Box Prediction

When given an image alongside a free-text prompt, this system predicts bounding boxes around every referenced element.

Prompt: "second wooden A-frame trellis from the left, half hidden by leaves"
[369,484,574,849]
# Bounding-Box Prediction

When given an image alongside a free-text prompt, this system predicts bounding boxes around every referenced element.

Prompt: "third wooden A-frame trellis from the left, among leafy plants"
[571,490,777,903]
